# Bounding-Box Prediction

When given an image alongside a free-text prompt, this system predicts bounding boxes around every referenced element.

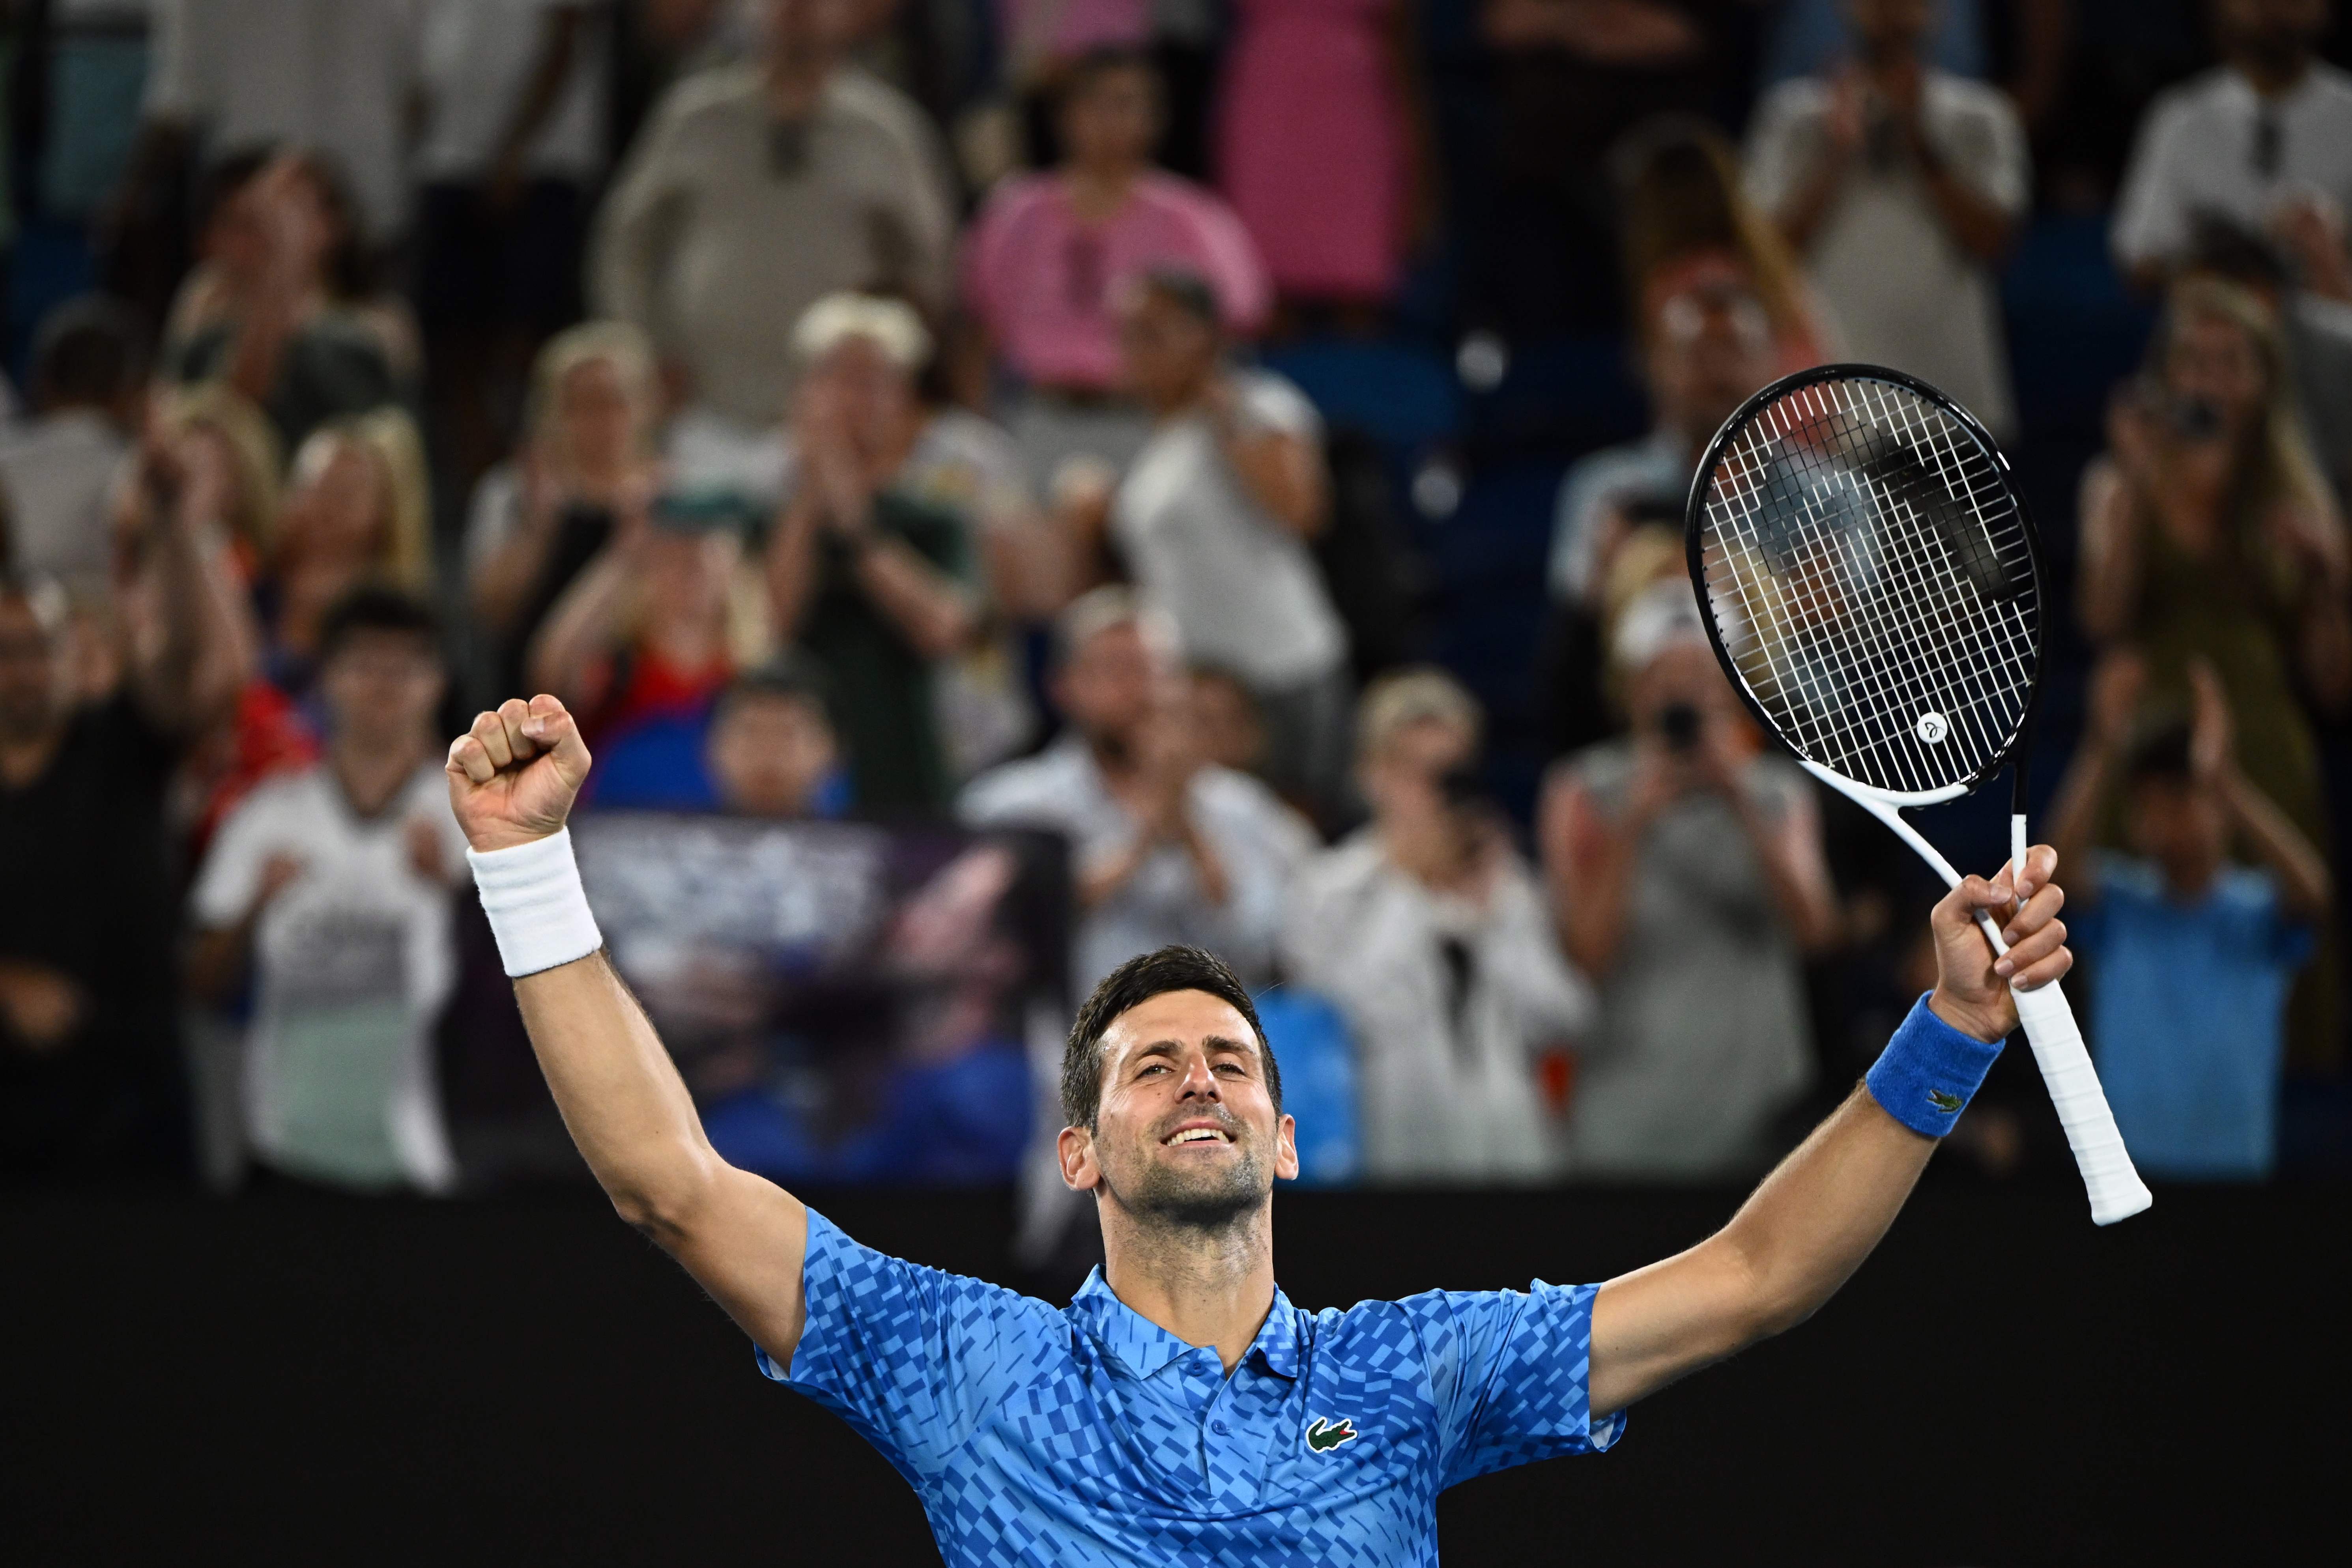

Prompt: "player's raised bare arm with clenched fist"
[449,696,809,1366]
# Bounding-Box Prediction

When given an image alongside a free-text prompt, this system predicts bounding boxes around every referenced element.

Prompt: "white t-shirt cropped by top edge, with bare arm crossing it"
[416,0,604,181]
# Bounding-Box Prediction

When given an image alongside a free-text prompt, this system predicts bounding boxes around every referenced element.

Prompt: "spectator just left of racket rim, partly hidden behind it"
[1543,252,1773,755]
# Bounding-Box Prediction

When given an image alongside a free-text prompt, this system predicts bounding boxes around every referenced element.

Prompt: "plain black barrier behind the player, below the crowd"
[14,1171,2352,1568]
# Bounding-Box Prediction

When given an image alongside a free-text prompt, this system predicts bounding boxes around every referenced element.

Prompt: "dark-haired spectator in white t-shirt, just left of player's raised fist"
[188,585,466,1192]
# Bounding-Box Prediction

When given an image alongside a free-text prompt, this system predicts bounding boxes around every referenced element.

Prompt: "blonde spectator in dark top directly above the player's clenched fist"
[466,322,661,691]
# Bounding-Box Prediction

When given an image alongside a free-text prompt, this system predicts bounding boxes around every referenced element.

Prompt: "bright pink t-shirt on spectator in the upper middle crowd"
[964,169,1270,388]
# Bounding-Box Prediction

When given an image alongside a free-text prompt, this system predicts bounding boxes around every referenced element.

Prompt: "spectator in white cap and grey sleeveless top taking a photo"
[1541,581,1837,1180]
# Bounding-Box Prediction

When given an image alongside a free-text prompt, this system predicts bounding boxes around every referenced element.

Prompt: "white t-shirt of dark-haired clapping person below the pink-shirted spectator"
[1110,372,1348,691]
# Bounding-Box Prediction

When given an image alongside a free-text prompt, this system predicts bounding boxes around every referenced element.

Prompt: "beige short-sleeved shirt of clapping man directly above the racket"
[1748,71,2032,435]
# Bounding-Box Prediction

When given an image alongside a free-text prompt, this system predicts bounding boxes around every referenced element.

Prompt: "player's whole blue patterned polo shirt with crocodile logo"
[760,1208,1625,1568]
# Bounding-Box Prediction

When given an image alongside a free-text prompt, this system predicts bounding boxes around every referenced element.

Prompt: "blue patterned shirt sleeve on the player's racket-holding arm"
[1402,1279,1625,1488]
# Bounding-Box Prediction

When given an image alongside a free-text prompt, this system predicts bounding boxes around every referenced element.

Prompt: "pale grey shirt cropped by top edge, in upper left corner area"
[146,0,416,242]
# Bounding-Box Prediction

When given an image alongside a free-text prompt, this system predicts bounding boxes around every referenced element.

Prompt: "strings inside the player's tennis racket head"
[1701,381,2039,792]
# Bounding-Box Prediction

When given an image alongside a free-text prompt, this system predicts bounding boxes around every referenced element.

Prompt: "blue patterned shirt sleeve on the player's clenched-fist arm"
[757,1208,1068,1483]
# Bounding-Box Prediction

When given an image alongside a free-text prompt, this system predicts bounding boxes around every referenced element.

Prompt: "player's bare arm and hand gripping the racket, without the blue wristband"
[1590,846,2074,1415]
